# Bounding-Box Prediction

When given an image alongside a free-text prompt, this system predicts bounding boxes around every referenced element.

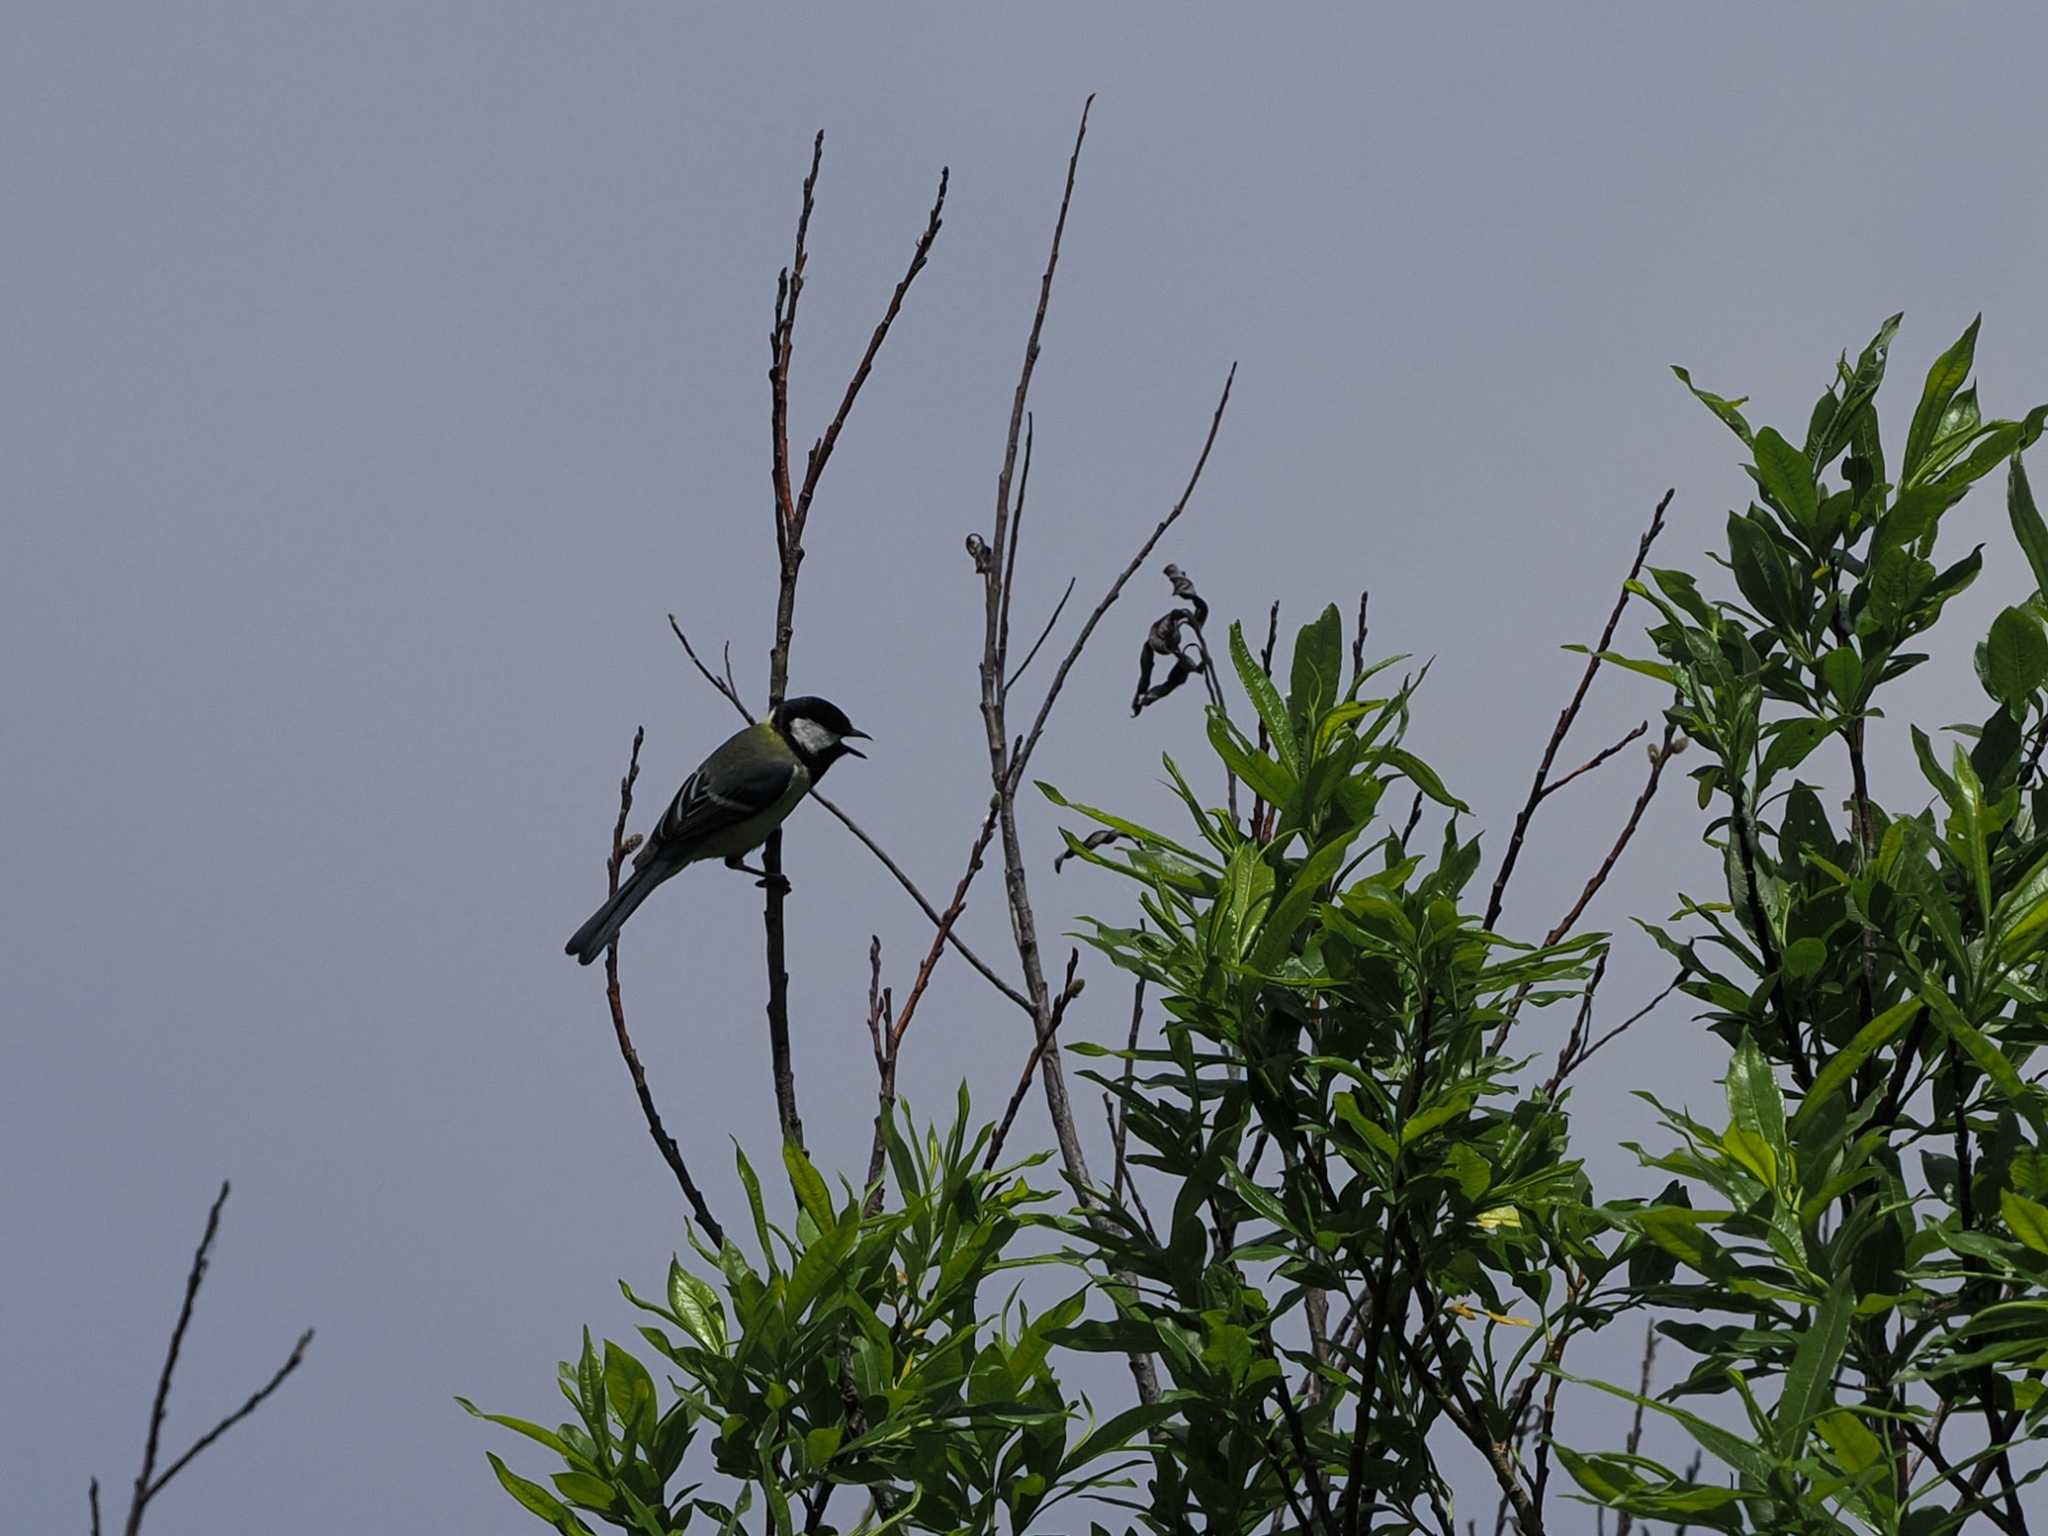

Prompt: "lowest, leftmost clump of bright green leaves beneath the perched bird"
[463,1092,1159,1536]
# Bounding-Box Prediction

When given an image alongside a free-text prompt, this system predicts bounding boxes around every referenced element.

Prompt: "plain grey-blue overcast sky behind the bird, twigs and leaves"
[0,0,2048,1536]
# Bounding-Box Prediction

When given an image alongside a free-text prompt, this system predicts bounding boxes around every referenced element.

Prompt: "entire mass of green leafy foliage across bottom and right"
[468,319,2048,1536]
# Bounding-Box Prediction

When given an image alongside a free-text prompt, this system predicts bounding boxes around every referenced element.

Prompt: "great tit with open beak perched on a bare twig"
[565,698,868,965]
